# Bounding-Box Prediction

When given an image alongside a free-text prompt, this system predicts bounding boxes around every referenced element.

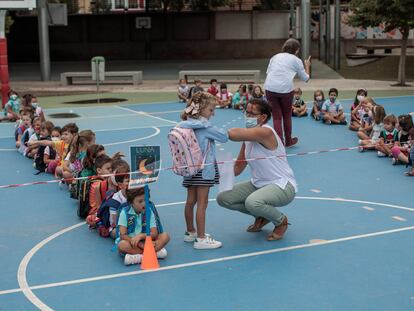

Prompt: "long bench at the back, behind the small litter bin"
[60,71,142,85]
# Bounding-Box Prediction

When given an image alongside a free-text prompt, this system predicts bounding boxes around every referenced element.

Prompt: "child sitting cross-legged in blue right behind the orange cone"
[115,188,170,265]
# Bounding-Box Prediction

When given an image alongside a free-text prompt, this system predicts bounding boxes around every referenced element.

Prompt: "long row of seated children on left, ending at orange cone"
[8,97,169,265]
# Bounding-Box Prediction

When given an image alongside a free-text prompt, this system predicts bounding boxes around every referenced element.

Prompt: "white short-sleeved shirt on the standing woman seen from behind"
[264,53,309,93]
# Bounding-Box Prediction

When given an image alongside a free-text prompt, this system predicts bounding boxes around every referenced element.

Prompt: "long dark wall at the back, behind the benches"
[8,11,288,62]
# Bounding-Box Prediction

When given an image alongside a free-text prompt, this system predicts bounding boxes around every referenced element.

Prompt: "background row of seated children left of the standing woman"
[177,79,266,111]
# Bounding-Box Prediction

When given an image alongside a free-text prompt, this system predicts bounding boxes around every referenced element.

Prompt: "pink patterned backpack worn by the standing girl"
[168,127,207,177]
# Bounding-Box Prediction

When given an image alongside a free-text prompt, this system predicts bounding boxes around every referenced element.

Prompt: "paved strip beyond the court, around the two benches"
[6,59,414,95]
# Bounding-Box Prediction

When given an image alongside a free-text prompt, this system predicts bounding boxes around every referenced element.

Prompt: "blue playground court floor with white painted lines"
[0,96,414,311]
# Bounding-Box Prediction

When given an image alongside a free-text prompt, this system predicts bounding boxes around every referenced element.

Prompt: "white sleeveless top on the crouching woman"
[245,124,298,192]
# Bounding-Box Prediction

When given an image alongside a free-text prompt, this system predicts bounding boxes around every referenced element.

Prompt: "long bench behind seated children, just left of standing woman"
[179,70,260,84]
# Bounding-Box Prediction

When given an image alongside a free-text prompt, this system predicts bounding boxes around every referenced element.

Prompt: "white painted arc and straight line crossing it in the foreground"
[0,197,414,310]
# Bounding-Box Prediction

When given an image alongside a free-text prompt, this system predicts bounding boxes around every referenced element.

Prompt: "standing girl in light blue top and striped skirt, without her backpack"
[177,92,228,249]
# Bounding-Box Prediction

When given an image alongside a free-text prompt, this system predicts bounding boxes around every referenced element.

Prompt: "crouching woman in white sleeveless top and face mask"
[217,99,297,241]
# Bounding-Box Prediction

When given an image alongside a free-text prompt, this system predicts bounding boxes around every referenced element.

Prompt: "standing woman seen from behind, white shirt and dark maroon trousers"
[264,39,311,147]
